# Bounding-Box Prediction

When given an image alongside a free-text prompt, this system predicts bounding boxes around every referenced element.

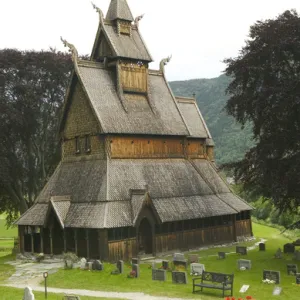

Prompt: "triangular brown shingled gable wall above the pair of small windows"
[64,83,100,139]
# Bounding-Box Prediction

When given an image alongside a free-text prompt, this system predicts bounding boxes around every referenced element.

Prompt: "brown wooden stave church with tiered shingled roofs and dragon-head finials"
[17,0,252,261]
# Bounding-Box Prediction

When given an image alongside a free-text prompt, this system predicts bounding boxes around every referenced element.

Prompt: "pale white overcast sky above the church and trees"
[0,0,300,81]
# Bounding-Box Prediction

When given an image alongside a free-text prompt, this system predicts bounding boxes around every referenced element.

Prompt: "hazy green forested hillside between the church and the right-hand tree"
[170,75,253,165]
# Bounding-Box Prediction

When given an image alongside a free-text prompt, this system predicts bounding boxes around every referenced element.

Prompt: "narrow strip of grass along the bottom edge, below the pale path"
[0,286,125,300]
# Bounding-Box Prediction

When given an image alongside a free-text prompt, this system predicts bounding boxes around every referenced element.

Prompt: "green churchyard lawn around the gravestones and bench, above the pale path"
[44,223,300,300]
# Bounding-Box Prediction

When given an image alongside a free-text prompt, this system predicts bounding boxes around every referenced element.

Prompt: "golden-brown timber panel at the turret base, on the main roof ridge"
[119,63,148,93]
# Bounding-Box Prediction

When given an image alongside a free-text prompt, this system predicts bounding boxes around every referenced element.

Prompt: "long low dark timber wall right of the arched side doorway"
[155,225,234,253]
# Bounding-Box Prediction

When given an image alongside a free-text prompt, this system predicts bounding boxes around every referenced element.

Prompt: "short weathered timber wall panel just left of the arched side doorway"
[108,238,137,262]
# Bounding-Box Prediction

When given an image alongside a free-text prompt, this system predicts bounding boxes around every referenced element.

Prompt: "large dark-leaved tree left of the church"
[0,49,73,223]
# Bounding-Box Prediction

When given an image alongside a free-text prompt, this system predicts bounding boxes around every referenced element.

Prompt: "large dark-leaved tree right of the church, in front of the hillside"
[225,10,300,211]
